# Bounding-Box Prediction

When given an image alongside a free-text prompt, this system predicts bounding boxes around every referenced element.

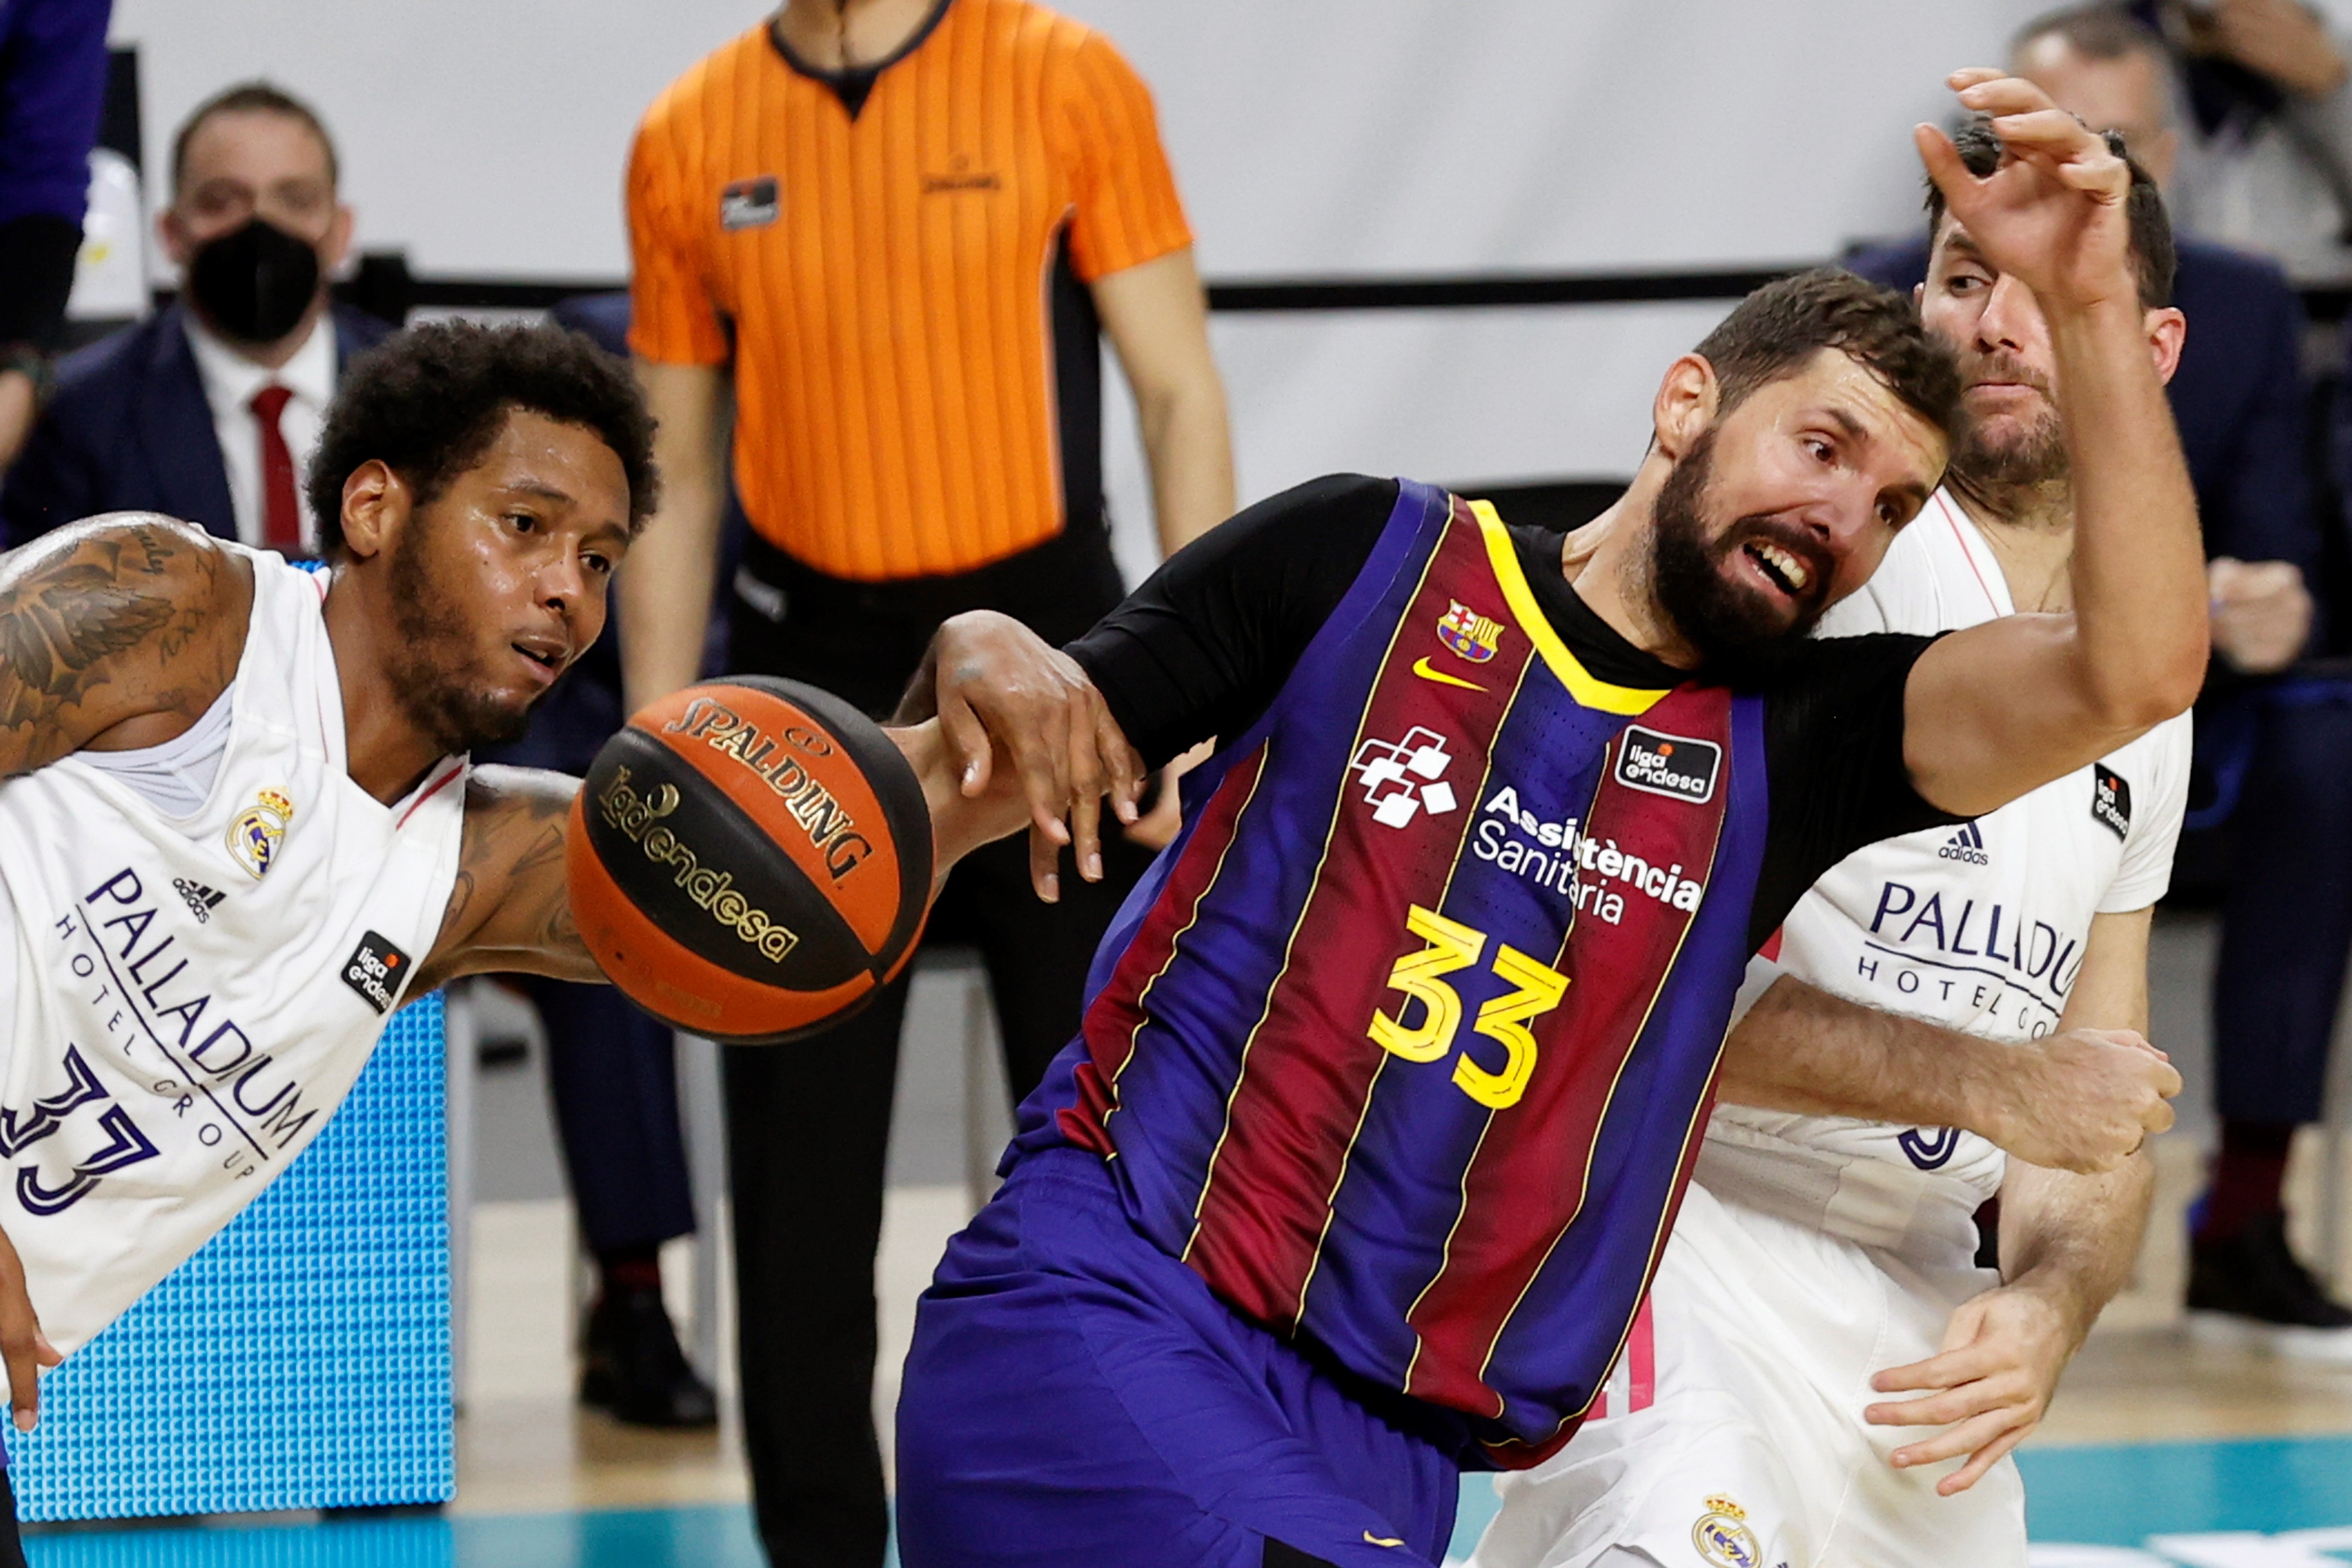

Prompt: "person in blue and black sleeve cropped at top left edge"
[0,0,113,472]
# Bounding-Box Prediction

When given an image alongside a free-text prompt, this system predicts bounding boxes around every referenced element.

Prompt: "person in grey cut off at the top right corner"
[2119,0,2352,282]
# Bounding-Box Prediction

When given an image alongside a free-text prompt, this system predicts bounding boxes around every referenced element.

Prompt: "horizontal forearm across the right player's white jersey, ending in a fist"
[1719,976,2016,1140]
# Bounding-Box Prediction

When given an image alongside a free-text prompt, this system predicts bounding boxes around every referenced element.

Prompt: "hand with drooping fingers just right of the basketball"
[891,609,1143,903]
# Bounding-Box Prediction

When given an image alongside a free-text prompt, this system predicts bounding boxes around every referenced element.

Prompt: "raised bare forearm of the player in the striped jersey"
[2049,299,2206,731]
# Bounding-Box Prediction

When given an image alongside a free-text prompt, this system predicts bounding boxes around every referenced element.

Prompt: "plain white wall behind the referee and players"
[115,0,2239,576]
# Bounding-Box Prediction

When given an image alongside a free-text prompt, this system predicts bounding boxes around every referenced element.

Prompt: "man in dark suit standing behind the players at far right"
[1851,0,2352,1357]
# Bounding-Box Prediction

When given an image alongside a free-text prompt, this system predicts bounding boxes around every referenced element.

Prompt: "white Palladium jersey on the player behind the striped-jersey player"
[1696,491,2190,1262]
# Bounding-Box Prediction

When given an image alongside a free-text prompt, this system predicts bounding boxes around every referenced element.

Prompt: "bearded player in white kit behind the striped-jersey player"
[1477,125,2190,1568]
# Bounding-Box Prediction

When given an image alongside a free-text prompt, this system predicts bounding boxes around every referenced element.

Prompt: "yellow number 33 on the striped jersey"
[1366,903,1569,1109]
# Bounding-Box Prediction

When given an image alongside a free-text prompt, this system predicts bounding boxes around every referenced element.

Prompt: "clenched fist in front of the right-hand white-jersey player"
[1978,1030,2180,1176]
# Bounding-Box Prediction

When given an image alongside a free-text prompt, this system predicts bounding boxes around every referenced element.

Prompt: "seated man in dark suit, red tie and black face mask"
[0,82,390,555]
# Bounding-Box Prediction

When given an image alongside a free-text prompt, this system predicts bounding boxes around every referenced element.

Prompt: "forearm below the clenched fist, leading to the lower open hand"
[2002,1152,2157,1344]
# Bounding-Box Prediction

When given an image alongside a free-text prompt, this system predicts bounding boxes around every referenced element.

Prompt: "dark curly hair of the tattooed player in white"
[306,322,661,555]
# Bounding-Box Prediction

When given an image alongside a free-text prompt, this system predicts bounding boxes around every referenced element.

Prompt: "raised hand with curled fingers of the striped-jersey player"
[1912,66,2138,310]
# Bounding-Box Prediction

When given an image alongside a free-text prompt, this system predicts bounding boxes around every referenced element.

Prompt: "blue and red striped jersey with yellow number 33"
[1014,484,1766,1467]
